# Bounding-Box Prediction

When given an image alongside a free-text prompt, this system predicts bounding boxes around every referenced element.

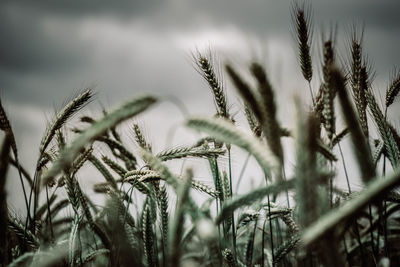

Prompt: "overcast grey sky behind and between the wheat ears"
[0,0,400,211]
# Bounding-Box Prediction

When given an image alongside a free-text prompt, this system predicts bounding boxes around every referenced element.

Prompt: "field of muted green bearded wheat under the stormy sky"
[0,5,400,267]
